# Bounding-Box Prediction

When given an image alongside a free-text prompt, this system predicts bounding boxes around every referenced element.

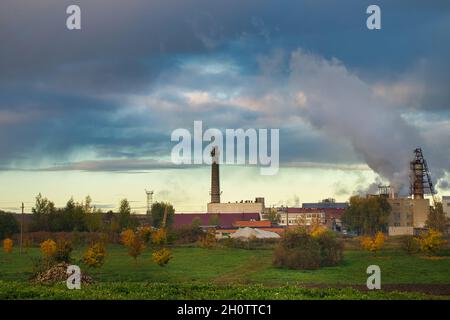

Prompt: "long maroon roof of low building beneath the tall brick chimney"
[174,212,260,228]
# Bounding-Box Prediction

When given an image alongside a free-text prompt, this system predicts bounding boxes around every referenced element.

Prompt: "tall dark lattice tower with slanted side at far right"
[410,148,436,203]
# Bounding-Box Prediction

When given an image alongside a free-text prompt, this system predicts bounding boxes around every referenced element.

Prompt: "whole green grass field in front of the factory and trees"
[0,245,450,299]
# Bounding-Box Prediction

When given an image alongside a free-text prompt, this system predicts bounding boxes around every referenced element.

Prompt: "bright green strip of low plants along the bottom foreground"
[0,281,443,300]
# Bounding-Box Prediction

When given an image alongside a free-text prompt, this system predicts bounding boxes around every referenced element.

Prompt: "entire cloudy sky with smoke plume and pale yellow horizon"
[0,0,450,213]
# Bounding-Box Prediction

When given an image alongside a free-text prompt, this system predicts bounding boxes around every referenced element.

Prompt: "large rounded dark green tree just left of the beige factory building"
[342,196,391,235]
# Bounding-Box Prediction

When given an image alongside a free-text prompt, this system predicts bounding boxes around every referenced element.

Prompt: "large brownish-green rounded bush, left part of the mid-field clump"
[273,231,321,269]
